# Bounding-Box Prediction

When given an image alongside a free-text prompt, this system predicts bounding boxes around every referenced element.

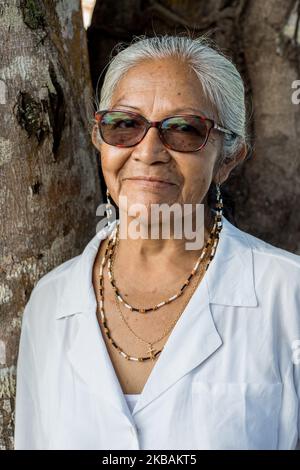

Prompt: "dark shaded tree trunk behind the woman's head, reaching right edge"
[88,0,300,254]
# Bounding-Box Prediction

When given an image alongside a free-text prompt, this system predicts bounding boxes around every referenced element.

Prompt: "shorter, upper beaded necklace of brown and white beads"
[108,213,219,313]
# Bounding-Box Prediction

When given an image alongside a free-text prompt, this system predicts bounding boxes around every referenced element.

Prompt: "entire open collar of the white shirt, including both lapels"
[57,213,257,421]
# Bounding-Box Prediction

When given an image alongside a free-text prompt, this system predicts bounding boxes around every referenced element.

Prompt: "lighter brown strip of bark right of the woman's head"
[239,0,300,250]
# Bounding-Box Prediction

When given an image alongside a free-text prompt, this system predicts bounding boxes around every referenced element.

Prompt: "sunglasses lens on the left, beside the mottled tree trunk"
[99,111,145,147]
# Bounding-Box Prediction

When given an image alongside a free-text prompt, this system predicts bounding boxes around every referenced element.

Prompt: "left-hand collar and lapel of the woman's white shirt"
[57,220,136,422]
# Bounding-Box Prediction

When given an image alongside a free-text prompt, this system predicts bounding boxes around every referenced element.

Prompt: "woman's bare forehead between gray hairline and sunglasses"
[112,58,213,115]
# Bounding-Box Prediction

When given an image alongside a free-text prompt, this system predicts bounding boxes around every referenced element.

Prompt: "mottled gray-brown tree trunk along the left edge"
[0,0,100,449]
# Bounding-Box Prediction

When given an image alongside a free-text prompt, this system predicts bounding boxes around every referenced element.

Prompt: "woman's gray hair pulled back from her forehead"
[98,34,251,169]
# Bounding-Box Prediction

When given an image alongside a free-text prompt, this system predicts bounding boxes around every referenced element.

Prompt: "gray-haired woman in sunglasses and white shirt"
[15,35,300,449]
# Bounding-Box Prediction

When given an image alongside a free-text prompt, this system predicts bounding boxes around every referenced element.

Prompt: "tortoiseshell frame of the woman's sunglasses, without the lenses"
[95,109,236,153]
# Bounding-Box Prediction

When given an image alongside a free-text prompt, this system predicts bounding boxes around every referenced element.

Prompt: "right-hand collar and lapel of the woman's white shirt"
[133,218,257,414]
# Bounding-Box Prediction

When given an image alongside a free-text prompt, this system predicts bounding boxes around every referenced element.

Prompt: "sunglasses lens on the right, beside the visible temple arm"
[161,116,209,152]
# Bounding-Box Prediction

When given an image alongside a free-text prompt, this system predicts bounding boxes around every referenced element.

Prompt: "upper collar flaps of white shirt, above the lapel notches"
[56,216,257,318]
